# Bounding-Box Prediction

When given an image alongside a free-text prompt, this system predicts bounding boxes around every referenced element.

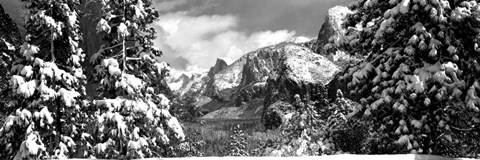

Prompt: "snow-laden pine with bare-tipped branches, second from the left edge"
[91,0,185,158]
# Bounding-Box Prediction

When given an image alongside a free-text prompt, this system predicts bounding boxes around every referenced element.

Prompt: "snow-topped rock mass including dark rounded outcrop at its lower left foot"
[262,44,339,128]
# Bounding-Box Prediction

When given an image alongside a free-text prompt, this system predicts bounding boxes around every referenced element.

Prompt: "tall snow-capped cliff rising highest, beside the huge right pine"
[314,6,353,55]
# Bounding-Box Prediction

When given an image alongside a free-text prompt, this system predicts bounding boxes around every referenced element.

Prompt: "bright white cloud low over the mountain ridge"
[153,12,295,70]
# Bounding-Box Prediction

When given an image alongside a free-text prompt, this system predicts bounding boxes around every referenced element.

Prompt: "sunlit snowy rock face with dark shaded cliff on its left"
[264,43,339,106]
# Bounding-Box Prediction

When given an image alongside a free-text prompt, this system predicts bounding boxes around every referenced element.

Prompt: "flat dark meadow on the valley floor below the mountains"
[184,119,282,156]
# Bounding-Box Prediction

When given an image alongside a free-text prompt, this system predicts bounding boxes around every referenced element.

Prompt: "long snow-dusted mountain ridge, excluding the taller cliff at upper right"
[169,42,339,118]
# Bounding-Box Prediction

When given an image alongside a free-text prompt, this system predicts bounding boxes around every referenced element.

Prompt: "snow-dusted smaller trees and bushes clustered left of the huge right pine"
[264,95,340,156]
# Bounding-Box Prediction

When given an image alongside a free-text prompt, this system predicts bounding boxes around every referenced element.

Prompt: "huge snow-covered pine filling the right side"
[330,0,480,158]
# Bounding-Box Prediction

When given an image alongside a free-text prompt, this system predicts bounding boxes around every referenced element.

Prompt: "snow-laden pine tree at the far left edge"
[0,0,89,159]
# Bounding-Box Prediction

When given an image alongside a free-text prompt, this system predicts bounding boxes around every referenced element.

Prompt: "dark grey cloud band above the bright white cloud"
[197,0,356,37]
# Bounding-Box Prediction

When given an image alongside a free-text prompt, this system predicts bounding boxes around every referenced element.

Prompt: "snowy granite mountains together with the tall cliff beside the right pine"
[169,7,352,124]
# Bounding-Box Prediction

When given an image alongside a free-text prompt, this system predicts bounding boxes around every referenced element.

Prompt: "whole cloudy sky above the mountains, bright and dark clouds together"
[0,0,353,70]
